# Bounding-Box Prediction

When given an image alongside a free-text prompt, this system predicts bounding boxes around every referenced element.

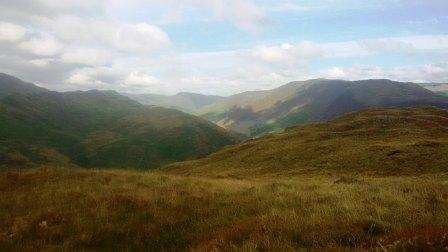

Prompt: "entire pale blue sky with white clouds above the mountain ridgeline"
[0,0,448,95]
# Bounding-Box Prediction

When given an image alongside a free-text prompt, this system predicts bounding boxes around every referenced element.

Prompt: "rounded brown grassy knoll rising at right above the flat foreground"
[161,107,448,177]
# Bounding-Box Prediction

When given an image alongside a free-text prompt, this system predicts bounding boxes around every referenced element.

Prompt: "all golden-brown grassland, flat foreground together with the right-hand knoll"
[0,108,448,251]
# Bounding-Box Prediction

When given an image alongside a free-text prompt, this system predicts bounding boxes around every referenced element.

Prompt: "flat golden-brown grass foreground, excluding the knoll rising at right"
[0,168,448,251]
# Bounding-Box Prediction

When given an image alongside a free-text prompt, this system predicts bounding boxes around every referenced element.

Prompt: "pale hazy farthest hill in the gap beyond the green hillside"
[124,92,224,114]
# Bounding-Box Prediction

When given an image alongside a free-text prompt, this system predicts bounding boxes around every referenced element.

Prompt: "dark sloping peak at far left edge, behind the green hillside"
[0,73,48,99]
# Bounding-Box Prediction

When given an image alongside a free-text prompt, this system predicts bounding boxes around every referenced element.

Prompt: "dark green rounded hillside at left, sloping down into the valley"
[0,73,239,169]
